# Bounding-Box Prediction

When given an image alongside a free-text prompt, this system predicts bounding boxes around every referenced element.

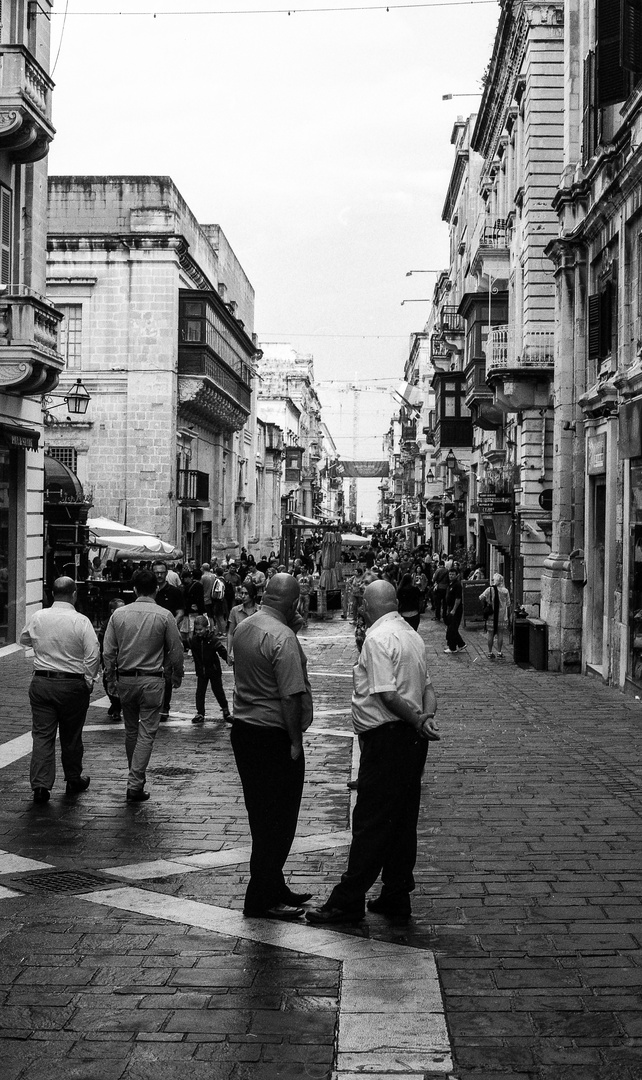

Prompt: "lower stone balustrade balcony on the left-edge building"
[0,284,65,395]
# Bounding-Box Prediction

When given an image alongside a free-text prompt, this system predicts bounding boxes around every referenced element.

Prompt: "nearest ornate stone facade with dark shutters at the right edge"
[543,0,642,694]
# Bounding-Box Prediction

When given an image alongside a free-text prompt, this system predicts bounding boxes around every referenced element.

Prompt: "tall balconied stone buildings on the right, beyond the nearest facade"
[410,0,564,615]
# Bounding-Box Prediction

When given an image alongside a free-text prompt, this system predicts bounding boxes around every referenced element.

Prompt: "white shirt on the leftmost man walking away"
[21,600,101,686]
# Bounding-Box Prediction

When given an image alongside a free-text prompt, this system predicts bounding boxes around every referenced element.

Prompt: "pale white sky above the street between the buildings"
[50,0,499,517]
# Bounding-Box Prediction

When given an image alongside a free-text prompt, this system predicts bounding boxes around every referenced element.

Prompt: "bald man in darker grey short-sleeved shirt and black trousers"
[231,573,312,919]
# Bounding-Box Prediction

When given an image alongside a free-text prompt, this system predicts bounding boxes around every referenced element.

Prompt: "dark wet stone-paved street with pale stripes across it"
[0,616,642,1080]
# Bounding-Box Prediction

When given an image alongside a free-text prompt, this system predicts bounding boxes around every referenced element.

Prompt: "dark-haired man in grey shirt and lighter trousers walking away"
[103,570,183,802]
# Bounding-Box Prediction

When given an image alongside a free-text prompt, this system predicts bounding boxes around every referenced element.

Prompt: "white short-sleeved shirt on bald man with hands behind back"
[352,611,430,733]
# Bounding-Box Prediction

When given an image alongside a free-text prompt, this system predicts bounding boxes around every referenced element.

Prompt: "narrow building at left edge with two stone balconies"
[0,0,63,651]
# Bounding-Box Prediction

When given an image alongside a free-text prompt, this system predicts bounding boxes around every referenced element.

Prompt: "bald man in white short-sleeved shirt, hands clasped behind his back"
[306,581,440,924]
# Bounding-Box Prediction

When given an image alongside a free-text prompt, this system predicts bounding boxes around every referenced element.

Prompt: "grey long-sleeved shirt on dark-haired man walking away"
[103,596,184,678]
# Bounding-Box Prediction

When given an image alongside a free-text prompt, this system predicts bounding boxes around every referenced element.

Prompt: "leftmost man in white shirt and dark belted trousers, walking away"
[21,578,101,802]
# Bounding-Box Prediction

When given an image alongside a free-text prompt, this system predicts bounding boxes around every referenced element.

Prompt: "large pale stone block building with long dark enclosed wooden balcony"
[46,176,260,562]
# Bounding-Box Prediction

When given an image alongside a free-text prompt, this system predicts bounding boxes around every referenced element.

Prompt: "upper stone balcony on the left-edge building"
[0,44,55,164]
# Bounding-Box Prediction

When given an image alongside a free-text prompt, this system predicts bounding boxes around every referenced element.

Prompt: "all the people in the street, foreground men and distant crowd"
[21,527,510,923]
